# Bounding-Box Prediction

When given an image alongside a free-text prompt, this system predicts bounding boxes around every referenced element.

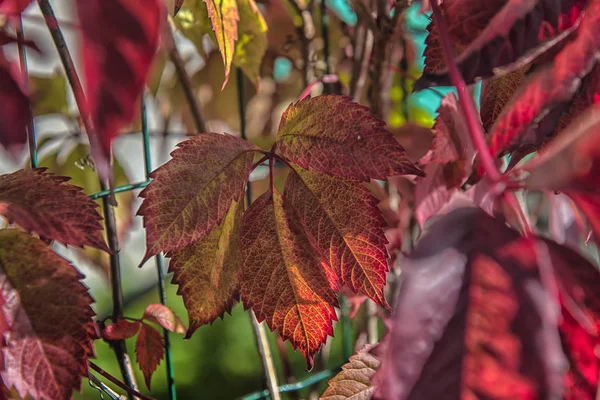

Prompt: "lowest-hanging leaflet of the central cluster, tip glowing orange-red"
[240,189,338,368]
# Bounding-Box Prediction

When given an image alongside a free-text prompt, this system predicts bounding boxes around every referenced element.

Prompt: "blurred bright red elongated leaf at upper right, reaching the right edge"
[490,0,600,156]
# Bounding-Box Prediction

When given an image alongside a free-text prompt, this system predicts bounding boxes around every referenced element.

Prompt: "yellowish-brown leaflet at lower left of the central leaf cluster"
[169,202,244,338]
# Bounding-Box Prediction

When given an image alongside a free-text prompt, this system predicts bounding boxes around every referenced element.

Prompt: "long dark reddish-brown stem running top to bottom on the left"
[38,0,137,389]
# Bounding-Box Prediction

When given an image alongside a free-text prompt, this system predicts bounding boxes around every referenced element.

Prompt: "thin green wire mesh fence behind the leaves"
[17,1,360,400]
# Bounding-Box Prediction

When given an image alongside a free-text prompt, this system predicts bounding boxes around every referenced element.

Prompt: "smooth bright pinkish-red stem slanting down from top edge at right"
[431,0,502,182]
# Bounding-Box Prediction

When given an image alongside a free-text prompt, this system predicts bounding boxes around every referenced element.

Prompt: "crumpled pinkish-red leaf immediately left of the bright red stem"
[415,93,475,226]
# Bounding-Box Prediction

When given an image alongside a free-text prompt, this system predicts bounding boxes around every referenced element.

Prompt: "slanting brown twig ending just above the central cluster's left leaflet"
[164,17,208,133]
